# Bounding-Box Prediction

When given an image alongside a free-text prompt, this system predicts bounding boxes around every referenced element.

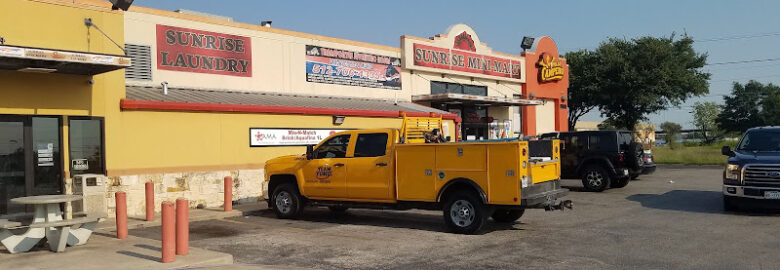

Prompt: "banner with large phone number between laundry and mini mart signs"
[306,45,401,90]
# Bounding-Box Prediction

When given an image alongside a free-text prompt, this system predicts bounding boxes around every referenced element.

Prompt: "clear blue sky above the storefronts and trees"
[131,0,780,128]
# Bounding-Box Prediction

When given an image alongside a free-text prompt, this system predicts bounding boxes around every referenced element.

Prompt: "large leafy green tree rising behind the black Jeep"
[596,34,710,130]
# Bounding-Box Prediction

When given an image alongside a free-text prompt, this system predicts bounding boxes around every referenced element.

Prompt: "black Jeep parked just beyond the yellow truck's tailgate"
[540,130,644,192]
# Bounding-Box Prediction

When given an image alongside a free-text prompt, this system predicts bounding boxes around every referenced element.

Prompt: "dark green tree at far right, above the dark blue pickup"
[716,80,780,133]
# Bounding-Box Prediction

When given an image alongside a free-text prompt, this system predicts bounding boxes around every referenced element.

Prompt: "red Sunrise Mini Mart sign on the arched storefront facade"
[414,43,522,79]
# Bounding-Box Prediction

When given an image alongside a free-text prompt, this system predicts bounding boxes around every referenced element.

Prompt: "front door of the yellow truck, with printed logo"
[302,134,351,198]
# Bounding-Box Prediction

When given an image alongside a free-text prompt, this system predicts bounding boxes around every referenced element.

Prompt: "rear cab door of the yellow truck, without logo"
[347,132,394,200]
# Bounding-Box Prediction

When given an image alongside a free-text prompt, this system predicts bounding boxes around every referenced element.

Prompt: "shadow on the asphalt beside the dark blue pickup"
[626,190,780,215]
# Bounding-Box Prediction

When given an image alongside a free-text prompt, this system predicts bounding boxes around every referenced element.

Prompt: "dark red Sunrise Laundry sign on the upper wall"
[152,24,252,77]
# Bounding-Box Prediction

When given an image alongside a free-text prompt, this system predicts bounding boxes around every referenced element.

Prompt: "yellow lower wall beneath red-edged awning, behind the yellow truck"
[106,111,455,176]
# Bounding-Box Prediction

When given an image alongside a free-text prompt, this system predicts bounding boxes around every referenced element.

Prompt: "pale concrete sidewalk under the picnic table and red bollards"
[0,202,266,269]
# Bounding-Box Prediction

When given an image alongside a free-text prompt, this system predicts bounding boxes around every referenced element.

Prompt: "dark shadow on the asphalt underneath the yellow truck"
[250,207,522,234]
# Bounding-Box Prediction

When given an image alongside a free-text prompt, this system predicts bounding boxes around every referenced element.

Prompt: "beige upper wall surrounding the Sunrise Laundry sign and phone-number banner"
[125,11,411,100]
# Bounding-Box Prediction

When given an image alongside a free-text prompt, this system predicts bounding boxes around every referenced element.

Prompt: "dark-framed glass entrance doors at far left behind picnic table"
[0,115,63,216]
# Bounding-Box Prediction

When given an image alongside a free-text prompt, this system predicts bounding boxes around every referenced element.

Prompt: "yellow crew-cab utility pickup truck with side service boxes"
[265,115,571,233]
